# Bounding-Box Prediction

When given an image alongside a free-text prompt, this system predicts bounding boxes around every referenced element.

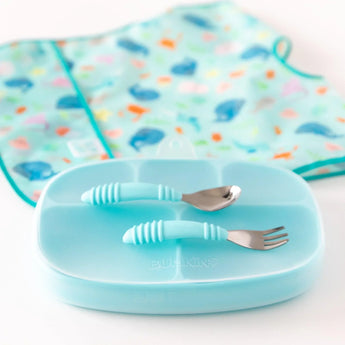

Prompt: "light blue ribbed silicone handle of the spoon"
[81,183,182,205]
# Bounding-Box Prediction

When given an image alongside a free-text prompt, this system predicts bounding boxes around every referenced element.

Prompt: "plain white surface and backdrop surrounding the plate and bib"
[0,0,345,345]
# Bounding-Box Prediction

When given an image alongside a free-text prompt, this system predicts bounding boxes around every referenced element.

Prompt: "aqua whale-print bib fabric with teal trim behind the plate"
[0,2,345,204]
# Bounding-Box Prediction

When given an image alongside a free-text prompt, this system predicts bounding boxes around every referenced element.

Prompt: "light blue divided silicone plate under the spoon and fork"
[35,159,323,314]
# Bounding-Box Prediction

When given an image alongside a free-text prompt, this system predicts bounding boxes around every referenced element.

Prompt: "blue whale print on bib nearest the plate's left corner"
[13,161,56,181]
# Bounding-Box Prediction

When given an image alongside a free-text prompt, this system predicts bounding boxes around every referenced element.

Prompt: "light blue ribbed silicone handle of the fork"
[122,220,228,244]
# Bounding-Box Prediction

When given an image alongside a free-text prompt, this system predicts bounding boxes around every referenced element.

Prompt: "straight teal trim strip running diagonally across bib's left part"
[50,41,114,158]
